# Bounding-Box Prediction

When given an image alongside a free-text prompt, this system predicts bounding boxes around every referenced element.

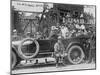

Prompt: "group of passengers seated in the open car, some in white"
[43,23,87,39]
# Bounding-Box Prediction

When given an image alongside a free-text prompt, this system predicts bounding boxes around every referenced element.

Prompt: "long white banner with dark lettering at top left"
[12,1,44,12]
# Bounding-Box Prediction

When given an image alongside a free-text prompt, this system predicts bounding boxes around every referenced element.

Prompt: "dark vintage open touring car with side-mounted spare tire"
[11,35,90,69]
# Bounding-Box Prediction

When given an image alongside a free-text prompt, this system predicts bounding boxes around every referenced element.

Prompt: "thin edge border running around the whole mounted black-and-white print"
[10,0,97,75]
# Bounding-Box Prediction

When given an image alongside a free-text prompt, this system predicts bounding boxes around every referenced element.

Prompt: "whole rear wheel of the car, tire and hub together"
[68,45,84,64]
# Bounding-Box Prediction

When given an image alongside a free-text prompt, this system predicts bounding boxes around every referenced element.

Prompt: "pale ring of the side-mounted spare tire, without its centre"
[18,38,39,59]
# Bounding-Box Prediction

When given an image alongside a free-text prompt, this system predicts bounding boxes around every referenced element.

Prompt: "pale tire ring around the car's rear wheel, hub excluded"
[67,45,85,65]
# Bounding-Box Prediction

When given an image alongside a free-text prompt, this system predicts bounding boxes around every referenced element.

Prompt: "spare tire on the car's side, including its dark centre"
[18,38,39,59]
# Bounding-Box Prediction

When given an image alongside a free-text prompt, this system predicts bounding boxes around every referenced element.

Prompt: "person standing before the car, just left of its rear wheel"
[54,36,65,67]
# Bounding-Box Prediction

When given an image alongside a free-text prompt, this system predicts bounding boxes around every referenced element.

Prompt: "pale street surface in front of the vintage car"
[12,63,95,74]
